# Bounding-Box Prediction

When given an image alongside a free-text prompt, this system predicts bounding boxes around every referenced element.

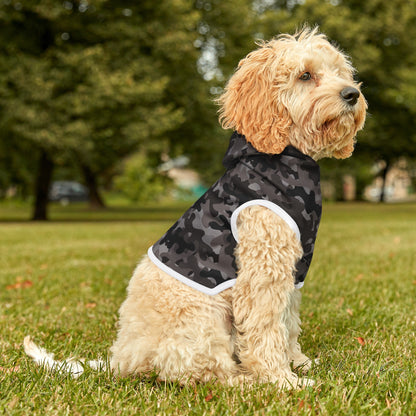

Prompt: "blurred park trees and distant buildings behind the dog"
[0,0,416,220]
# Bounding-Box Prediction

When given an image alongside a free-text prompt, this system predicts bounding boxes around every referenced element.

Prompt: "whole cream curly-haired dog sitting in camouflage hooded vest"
[25,28,367,387]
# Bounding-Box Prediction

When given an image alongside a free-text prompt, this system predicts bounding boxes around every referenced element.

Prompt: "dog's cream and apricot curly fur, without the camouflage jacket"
[26,29,367,387]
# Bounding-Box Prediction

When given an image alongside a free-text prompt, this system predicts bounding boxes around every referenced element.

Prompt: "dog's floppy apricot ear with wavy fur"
[217,44,292,154]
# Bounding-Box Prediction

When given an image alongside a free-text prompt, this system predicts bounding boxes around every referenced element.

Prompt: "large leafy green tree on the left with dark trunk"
[0,0,196,219]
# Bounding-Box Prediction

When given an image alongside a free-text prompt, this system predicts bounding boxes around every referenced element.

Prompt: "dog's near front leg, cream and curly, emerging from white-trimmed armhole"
[233,206,312,387]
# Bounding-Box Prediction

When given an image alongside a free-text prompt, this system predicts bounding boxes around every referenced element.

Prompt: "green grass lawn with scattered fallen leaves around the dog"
[0,204,416,416]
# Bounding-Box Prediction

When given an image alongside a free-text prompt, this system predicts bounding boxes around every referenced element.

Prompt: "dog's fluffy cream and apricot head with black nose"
[218,28,367,159]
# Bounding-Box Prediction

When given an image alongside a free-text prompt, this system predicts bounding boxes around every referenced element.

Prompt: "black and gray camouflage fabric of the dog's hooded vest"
[152,133,322,289]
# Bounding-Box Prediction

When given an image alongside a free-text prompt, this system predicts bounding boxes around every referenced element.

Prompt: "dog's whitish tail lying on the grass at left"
[23,335,107,378]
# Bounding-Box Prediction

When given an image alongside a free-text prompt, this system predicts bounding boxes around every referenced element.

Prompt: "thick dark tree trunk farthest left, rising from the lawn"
[32,150,54,221]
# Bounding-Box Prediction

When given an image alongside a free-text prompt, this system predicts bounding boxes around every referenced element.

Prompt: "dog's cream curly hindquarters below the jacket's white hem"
[111,258,242,383]
